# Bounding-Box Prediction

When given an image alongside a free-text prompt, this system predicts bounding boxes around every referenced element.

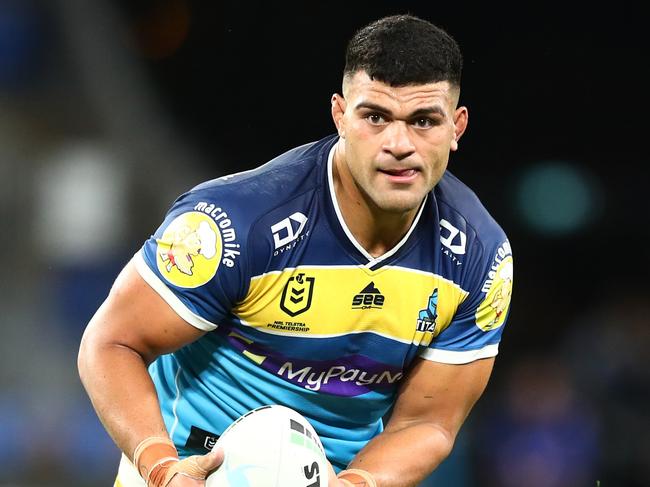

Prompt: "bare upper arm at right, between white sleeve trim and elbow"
[386,357,494,438]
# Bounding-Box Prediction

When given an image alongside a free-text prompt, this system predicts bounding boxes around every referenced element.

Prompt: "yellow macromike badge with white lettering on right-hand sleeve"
[475,242,513,331]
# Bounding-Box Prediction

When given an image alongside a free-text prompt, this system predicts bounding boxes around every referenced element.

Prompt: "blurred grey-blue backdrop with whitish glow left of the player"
[0,0,200,487]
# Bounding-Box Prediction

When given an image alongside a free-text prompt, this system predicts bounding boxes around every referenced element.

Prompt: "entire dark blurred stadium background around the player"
[0,0,650,487]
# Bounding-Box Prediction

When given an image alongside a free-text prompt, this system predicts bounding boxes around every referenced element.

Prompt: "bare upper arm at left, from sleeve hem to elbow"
[82,261,205,363]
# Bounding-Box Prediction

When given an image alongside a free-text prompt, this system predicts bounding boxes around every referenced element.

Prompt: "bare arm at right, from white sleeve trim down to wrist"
[349,358,494,487]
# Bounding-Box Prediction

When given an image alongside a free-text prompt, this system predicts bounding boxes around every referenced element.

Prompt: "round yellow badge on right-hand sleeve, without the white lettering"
[476,256,513,331]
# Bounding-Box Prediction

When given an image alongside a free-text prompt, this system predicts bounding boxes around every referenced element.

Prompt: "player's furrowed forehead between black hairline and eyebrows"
[343,71,456,111]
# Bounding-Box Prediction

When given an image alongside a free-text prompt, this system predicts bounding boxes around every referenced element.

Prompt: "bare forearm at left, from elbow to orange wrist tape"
[79,339,167,459]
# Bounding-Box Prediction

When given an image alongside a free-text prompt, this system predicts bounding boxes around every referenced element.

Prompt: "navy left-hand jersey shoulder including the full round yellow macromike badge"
[144,134,333,302]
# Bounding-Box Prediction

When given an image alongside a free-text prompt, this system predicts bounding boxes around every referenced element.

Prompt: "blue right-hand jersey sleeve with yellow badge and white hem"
[420,236,513,364]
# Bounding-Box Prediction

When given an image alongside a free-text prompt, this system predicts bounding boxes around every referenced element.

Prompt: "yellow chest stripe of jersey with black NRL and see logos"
[233,266,467,345]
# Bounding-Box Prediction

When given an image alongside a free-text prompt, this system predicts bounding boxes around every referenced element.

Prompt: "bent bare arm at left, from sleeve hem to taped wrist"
[78,262,204,458]
